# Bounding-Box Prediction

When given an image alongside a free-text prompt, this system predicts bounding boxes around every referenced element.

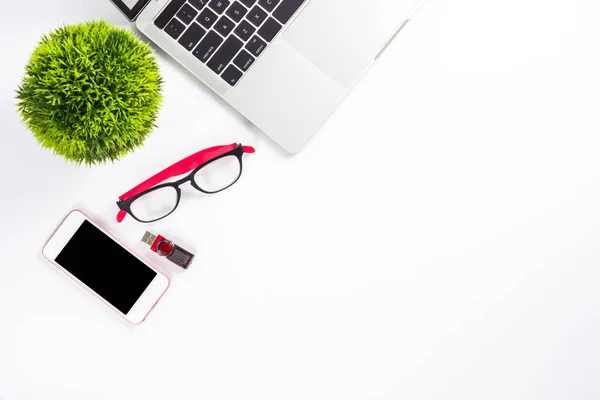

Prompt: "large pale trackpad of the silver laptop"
[283,0,414,87]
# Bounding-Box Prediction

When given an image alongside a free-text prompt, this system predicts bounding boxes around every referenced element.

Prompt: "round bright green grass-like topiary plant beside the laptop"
[17,21,162,165]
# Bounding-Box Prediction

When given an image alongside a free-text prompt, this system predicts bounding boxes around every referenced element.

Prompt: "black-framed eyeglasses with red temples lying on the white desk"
[117,143,255,223]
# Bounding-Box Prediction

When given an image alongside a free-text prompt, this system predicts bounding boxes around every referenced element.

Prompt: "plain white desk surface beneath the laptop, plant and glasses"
[0,0,600,400]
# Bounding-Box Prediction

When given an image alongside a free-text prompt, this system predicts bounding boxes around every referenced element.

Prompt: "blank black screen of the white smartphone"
[54,220,157,314]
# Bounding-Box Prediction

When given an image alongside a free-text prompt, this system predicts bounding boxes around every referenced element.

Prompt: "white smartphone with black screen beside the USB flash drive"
[42,210,170,324]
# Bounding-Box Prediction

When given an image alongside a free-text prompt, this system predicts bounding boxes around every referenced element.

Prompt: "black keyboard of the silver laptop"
[154,0,306,86]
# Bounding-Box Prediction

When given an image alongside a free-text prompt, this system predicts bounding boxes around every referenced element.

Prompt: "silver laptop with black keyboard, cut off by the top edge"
[111,0,424,153]
